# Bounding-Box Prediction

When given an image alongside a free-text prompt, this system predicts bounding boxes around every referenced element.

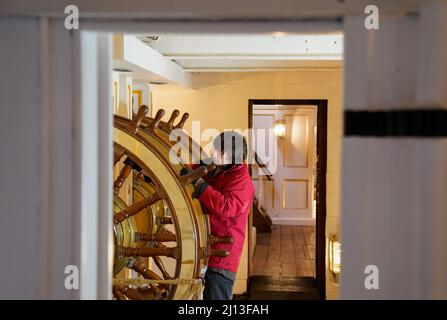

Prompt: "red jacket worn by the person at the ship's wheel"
[192,164,254,272]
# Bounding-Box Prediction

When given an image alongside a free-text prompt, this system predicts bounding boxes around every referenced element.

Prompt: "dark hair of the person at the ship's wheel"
[213,131,247,164]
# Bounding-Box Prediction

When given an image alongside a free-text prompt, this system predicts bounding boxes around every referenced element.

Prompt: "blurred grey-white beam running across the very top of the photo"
[0,0,428,21]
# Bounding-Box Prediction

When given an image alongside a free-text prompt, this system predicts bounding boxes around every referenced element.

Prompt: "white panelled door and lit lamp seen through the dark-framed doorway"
[253,105,317,225]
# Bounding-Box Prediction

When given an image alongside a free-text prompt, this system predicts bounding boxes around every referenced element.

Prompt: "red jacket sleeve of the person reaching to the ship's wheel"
[198,182,252,218]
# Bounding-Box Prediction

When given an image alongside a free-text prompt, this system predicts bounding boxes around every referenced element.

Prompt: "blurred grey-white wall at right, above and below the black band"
[340,11,447,299]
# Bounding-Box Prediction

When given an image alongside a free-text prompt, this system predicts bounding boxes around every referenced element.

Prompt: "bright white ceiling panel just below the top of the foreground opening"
[138,33,343,60]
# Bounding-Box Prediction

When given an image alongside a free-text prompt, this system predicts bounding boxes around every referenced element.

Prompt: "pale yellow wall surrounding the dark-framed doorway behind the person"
[152,68,342,299]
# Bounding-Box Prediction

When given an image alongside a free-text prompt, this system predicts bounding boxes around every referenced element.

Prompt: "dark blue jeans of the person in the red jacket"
[203,270,234,300]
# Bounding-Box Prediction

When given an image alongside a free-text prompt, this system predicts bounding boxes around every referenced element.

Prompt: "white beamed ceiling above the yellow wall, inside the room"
[113,33,343,88]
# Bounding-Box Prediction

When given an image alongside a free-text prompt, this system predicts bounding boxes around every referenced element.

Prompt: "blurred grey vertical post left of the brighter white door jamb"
[46,20,83,299]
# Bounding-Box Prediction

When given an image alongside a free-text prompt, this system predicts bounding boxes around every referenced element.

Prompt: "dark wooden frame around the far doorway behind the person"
[248,99,328,300]
